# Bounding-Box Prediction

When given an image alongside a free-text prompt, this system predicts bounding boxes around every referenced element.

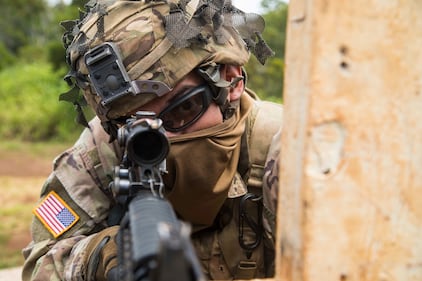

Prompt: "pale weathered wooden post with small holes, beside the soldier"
[275,0,422,281]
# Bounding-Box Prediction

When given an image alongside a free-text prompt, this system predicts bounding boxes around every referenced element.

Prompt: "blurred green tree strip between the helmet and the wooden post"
[246,0,288,102]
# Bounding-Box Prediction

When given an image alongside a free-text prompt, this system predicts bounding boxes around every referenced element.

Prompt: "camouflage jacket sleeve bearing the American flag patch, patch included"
[22,118,118,280]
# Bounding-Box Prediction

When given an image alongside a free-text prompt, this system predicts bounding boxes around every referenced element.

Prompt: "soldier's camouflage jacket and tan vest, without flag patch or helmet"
[23,90,281,280]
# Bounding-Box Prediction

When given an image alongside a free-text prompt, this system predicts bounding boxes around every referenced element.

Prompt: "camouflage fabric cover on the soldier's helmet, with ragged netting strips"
[62,0,273,126]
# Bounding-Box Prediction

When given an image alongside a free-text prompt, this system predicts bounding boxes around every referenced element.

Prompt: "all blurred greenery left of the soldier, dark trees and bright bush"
[0,0,86,142]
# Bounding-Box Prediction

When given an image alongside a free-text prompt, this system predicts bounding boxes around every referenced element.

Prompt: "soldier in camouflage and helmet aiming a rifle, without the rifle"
[22,0,282,280]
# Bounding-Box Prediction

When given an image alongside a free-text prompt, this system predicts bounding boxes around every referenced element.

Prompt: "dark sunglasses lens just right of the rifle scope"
[159,91,208,131]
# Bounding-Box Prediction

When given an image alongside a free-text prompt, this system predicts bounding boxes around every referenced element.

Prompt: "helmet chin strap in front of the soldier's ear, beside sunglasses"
[197,64,245,120]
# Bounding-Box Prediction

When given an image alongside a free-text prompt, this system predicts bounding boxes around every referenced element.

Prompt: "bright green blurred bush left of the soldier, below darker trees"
[0,62,85,141]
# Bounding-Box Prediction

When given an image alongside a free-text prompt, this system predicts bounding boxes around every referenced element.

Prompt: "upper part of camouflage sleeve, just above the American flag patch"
[53,118,118,223]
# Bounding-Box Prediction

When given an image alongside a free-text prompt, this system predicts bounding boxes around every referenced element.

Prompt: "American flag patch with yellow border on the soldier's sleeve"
[33,191,79,238]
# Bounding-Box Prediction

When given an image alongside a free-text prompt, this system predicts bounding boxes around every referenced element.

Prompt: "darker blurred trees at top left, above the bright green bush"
[0,0,86,70]
